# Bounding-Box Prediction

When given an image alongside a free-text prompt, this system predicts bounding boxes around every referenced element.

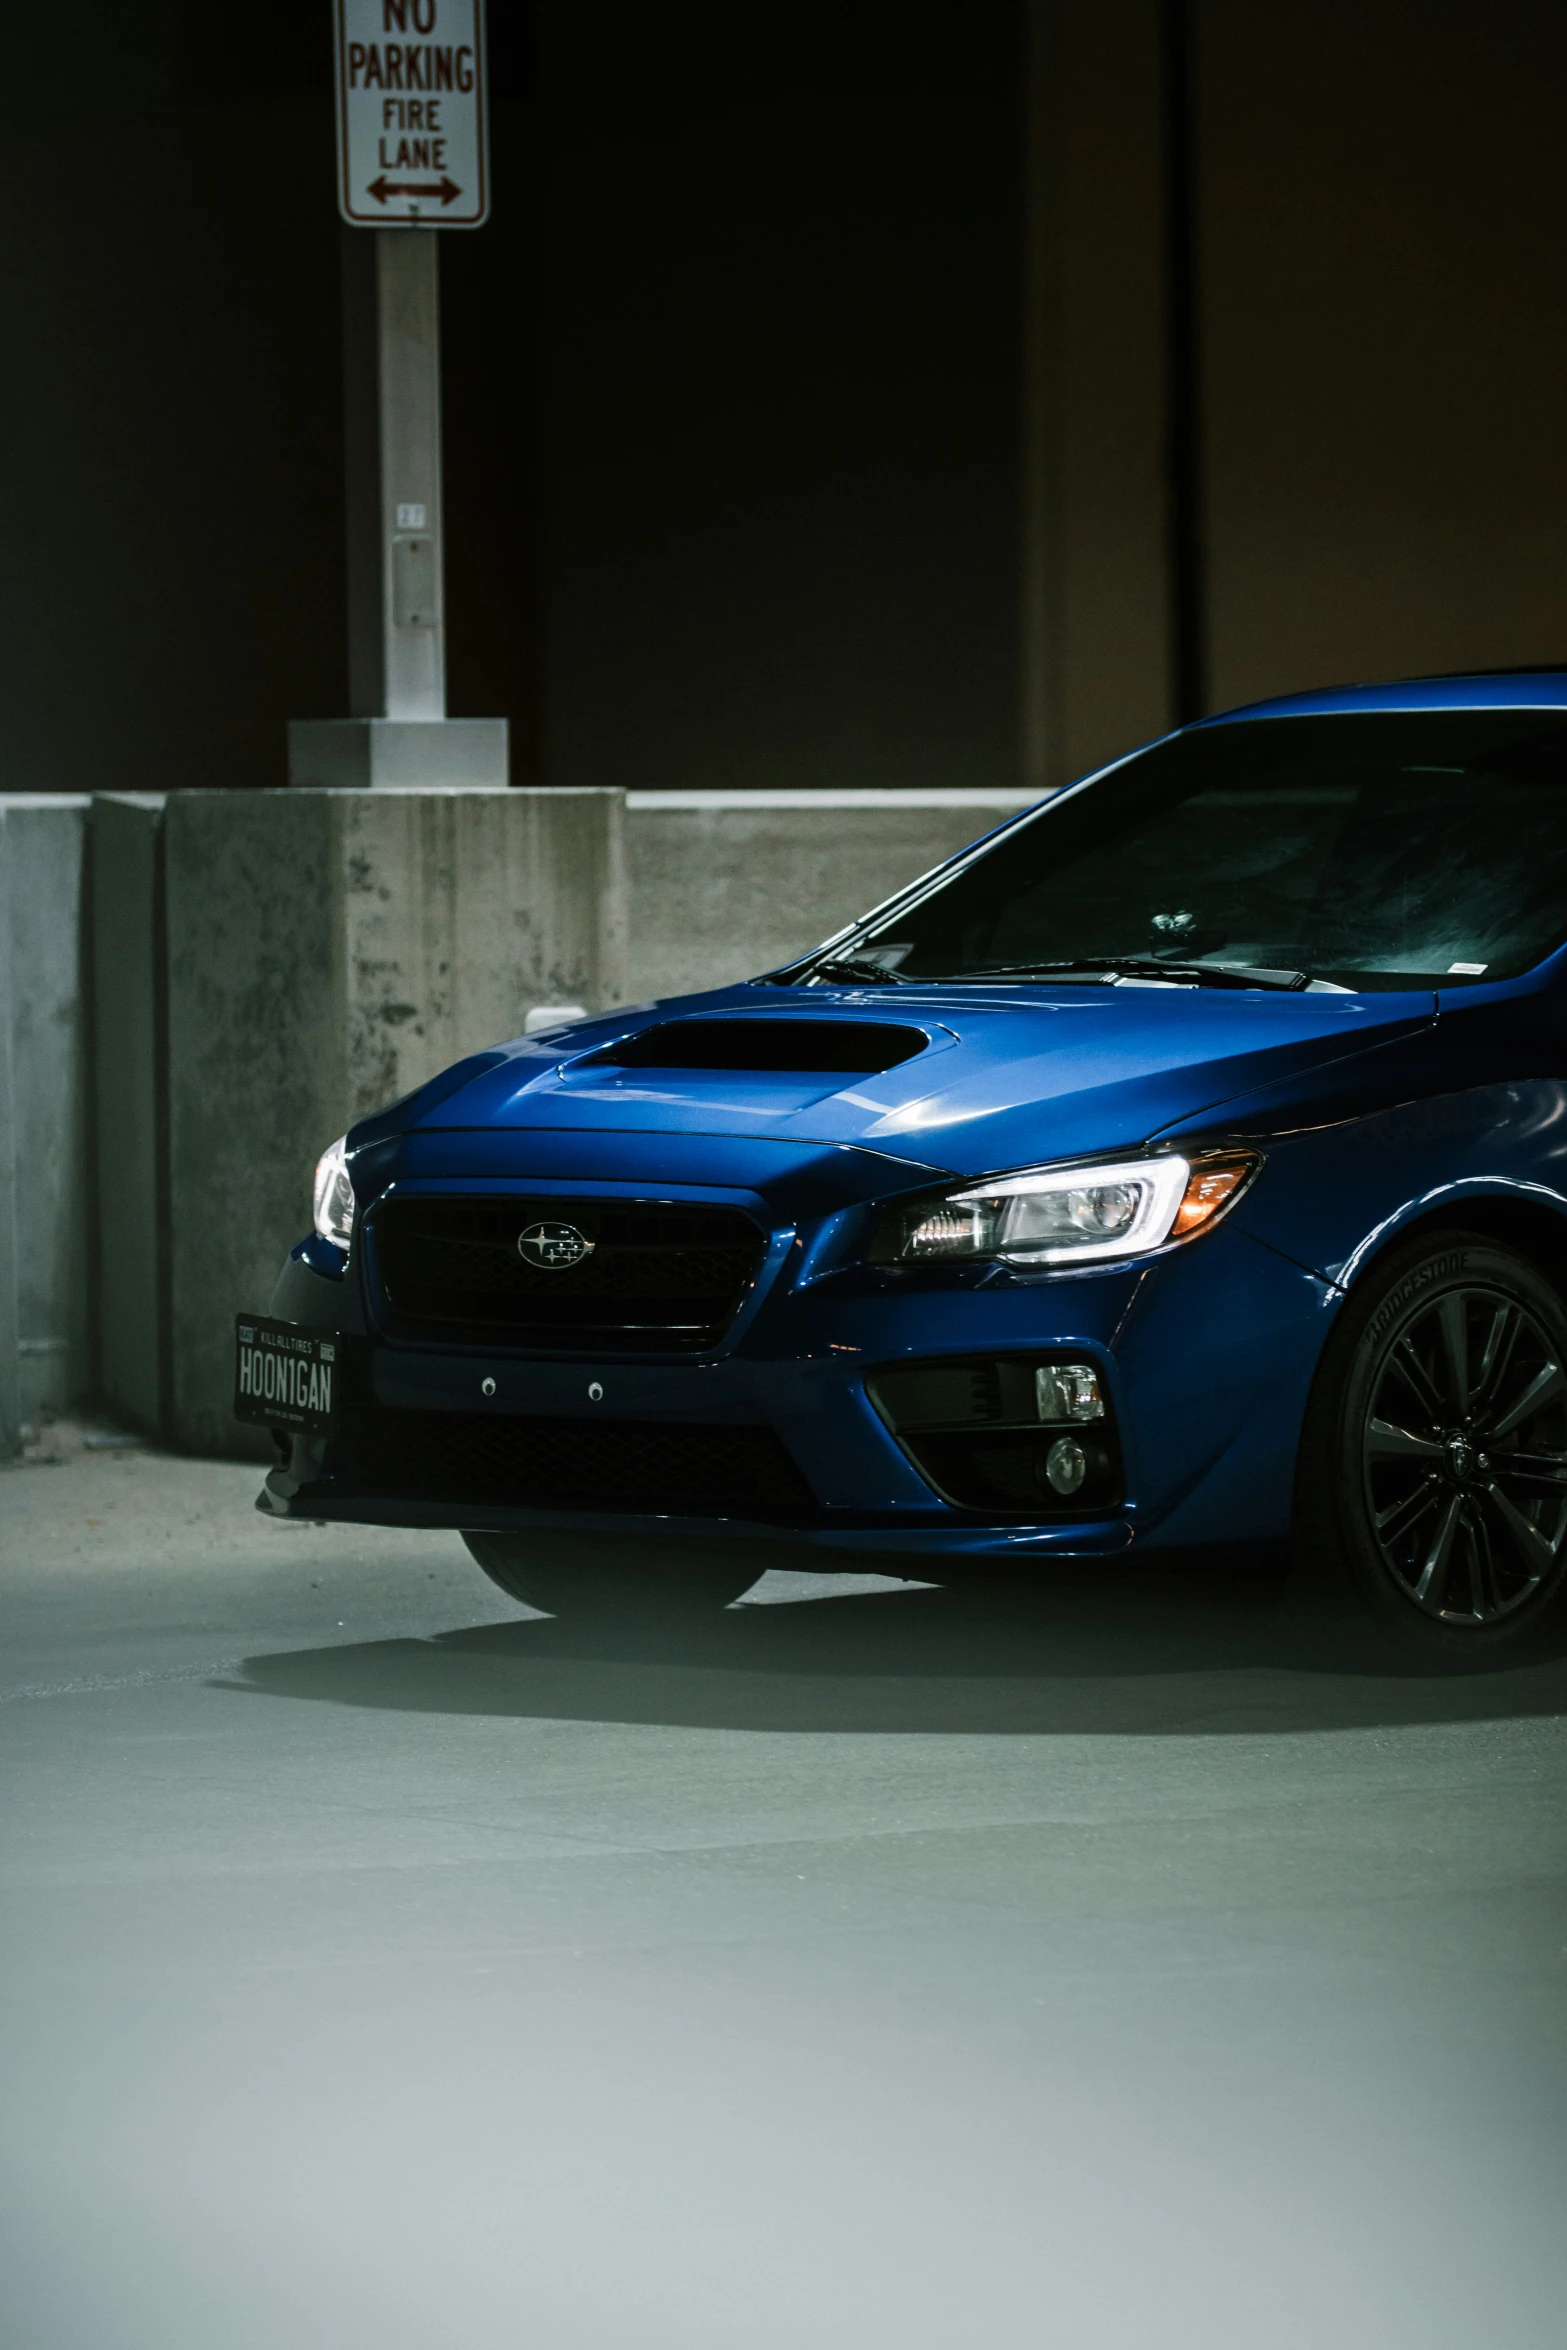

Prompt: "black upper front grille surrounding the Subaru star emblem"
[369,1199,766,1354]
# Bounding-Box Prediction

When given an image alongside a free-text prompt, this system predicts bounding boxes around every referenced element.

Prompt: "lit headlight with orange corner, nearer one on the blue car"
[874,1149,1262,1264]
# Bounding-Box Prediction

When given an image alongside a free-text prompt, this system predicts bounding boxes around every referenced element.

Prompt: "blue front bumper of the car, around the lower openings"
[261,1227,1337,1560]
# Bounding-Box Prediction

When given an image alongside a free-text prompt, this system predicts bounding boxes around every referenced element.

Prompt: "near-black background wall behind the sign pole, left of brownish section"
[0,0,1017,790]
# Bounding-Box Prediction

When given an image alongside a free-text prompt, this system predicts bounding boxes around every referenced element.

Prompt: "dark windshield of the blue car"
[834,710,1567,989]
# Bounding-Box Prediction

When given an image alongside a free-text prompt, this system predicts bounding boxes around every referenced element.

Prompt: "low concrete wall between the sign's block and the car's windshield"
[625,790,1031,999]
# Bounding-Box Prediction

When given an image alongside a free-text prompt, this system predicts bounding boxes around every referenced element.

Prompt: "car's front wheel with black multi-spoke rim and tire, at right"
[1294,1231,1567,1671]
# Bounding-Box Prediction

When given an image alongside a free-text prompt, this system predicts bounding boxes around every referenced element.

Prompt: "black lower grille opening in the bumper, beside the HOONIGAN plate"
[355,1412,815,1518]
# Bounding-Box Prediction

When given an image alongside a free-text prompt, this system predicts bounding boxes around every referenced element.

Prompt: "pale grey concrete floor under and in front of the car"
[0,1448,1567,2350]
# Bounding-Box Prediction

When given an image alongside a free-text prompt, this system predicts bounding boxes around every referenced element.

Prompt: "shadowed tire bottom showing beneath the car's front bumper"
[463,1535,766,1624]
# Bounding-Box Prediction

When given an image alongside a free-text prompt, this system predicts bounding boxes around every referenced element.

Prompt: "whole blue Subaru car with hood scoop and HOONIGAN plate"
[237,672,1567,1664]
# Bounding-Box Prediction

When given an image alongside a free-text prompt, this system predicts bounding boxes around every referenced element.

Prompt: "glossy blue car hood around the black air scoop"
[385,985,1435,1175]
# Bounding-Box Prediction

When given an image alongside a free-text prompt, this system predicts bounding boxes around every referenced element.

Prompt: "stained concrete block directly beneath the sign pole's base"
[162,790,625,1452]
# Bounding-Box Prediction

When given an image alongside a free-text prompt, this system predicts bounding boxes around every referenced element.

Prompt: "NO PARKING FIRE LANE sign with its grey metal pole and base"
[289,0,495,785]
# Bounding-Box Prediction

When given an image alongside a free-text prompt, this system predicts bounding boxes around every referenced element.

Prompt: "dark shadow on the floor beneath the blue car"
[218,1570,1567,1737]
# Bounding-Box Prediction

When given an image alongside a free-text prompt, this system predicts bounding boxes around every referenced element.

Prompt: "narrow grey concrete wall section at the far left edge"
[0,792,92,1424]
